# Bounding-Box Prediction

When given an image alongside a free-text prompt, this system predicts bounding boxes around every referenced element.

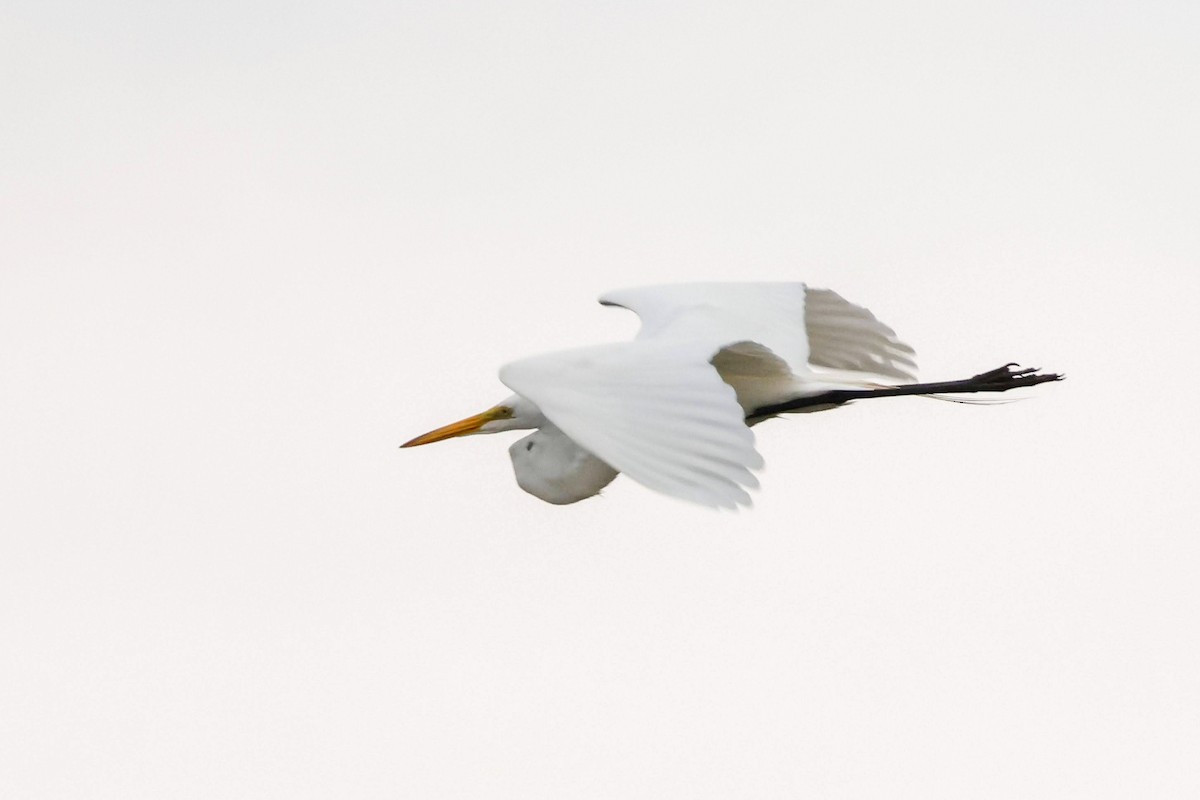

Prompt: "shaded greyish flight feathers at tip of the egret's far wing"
[804,289,917,380]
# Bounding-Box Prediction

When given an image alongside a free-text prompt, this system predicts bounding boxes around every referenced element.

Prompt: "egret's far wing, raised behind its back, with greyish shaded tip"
[600,283,917,380]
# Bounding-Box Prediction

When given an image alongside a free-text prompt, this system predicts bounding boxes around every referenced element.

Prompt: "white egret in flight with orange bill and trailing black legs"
[401,283,1062,509]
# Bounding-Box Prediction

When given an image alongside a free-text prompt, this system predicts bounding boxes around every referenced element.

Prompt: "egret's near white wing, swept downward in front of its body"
[500,341,762,507]
